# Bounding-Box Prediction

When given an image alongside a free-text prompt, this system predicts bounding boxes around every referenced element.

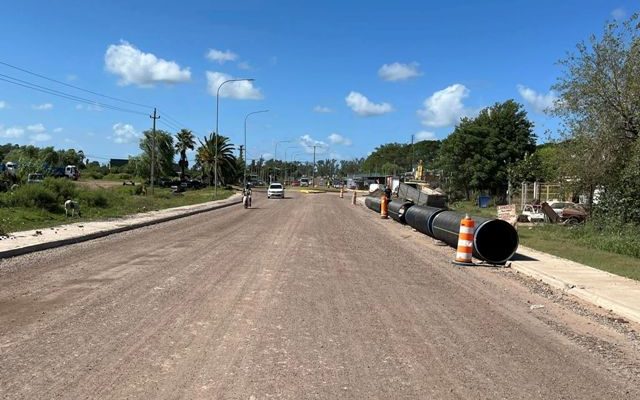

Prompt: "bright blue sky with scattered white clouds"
[0,0,640,163]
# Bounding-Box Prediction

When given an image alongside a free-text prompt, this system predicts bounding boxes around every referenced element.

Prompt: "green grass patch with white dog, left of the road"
[0,185,234,233]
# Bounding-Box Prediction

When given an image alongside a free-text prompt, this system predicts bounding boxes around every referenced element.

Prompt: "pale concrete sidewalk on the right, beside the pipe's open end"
[357,194,640,323]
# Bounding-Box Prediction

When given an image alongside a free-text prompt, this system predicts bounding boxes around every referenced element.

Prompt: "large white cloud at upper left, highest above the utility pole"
[104,41,191,86]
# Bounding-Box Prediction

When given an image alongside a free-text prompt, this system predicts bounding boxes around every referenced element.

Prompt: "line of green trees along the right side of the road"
[364,14,640,224]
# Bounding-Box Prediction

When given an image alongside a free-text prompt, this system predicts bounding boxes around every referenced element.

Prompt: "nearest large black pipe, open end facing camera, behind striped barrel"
[431,211,519,264]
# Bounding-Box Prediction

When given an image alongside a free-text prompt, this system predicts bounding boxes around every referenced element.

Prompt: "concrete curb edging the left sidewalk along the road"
[0,199,242,259]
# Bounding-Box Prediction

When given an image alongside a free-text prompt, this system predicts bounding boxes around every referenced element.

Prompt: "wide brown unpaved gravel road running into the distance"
[0,194,640,399]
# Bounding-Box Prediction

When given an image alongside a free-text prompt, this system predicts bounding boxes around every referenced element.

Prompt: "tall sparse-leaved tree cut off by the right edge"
[553,14,640,219]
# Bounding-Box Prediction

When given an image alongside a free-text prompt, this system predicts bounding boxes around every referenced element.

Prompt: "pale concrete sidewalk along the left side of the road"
[0,194,242,259]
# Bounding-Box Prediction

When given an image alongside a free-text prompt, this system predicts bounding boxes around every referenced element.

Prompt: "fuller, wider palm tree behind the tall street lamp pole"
[196,132,237,185]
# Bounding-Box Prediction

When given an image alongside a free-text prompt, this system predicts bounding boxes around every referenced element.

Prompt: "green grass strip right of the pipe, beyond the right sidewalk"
[518,225,640,280]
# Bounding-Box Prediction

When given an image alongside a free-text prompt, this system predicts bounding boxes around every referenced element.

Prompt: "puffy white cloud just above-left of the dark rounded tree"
[418,83,469,128]
